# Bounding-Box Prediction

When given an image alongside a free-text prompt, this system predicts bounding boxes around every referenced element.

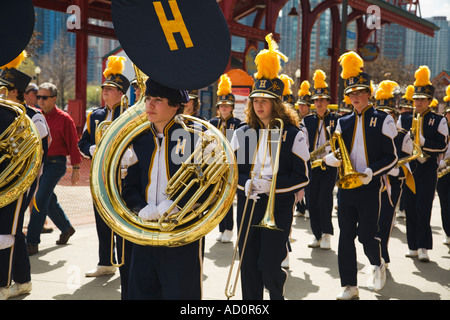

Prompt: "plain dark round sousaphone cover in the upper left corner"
[0,0,36,66]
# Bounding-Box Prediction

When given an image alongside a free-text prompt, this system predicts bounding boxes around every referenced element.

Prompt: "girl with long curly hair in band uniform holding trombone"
[231,34,309,300]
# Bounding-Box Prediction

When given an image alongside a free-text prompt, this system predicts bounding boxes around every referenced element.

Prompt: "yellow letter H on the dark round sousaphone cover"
[153,0,194,51]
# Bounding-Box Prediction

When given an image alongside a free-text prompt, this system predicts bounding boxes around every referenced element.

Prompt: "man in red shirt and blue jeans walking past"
[27,82,81,255]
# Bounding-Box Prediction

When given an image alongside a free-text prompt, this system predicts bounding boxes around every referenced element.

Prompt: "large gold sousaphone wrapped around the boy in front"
[91,99,238,247]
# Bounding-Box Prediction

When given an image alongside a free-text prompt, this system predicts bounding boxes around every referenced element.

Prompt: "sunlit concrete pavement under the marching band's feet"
[10,196,450,300]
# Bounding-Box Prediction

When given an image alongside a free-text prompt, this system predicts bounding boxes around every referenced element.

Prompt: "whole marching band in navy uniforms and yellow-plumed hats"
[0,36,450,300]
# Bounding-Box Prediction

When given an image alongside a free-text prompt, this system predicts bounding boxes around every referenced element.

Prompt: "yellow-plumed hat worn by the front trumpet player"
[339,51,371,95]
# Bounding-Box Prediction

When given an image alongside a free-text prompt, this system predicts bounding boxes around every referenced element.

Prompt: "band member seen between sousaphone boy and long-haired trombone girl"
[209,74,241,243]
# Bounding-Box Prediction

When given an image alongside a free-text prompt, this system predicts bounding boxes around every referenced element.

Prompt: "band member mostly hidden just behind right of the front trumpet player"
[375,80,412,268]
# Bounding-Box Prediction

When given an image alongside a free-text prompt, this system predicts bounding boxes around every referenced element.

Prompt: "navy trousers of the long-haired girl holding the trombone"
[237,194,294,300]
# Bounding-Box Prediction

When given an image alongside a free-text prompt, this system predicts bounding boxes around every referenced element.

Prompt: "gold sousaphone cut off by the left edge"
[0,91,43,208]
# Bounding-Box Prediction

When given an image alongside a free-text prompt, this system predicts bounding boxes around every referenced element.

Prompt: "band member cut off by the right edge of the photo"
[436,85,450,245]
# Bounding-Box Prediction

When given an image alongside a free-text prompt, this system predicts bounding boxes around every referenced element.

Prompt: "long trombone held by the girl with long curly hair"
[225,118,284,300]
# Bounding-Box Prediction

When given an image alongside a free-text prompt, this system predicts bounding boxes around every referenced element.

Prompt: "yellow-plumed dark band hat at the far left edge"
[0,50,31,92]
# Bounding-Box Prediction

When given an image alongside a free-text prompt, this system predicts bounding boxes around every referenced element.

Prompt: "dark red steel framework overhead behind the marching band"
[33,0,438,127]
